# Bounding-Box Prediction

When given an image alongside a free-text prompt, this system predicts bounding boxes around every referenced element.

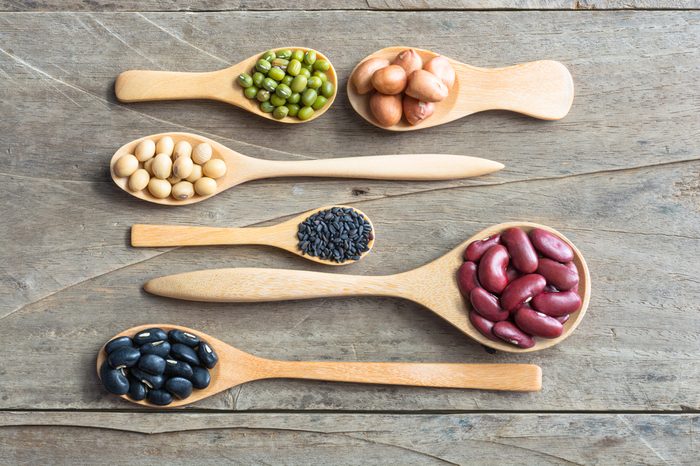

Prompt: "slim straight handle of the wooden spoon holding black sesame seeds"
[131,224,272,248]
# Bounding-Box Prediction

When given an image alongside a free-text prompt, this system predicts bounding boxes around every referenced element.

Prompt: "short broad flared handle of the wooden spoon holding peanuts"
[459,60,574,120]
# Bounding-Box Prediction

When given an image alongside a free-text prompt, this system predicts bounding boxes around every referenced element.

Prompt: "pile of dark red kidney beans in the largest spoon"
[457,228,581,348]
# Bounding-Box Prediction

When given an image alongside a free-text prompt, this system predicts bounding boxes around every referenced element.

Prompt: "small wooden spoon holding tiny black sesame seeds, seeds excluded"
[131,205,376,265]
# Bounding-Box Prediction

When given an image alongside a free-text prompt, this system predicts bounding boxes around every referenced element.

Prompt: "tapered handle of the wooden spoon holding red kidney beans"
[144,268,401,303]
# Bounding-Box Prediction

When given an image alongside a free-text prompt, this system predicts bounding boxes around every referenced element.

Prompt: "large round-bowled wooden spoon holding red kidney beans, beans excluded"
[144,222,591,353]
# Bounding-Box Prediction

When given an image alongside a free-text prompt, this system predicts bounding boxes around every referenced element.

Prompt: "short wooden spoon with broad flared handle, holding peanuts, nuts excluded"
[348,47,574,131]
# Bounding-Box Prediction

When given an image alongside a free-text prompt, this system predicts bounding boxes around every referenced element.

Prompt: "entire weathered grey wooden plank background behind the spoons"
[0,0,700,465]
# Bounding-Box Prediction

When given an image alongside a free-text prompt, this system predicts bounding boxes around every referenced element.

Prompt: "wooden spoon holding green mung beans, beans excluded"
[114,47,338,124]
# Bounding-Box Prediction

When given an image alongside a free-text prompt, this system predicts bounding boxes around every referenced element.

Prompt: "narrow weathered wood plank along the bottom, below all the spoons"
[0,412,700,465]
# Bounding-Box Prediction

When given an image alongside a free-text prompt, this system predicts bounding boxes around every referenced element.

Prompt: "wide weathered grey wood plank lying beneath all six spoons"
[0,12,700,411]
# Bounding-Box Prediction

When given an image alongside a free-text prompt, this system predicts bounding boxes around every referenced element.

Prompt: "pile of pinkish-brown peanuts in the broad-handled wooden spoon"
[350,49,455,126]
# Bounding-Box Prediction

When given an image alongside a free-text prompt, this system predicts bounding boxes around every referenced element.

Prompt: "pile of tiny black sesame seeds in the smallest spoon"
[297,207,374,263]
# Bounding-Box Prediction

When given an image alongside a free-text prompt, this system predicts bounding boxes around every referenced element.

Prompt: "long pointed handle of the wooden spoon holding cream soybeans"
[250,154,503,180]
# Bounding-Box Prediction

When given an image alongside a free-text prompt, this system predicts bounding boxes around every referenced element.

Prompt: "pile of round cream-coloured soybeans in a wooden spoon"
[114,136,226,201]
